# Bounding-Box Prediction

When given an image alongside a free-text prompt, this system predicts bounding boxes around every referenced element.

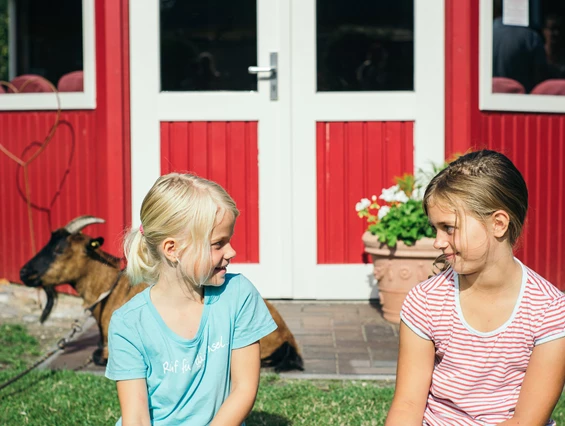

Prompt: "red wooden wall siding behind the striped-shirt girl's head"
[445,0,565,290]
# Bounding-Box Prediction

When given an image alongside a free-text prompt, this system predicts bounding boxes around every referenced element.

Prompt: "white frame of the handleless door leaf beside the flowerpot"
[290,0,445,299]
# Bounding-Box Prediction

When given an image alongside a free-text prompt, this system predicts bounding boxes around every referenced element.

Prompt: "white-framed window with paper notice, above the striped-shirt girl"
[480,0,565,112]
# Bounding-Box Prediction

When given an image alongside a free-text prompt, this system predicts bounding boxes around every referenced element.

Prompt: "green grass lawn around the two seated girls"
[0,325,565,426]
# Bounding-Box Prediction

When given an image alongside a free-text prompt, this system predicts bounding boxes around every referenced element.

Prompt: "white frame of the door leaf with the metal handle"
[130,0,293,298]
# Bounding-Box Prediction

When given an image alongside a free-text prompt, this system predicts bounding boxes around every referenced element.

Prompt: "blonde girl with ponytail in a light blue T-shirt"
[106,173,276,426]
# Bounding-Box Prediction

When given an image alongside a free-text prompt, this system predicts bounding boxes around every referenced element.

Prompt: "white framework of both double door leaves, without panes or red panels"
[130,0,444,299]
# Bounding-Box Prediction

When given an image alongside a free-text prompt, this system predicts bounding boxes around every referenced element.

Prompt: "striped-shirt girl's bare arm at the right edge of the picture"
[494,338,565,426]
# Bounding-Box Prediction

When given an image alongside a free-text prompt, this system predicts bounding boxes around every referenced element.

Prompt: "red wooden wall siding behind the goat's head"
[0,0,131,291]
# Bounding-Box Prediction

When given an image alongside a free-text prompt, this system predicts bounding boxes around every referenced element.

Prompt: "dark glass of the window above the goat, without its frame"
[0,0,83,92]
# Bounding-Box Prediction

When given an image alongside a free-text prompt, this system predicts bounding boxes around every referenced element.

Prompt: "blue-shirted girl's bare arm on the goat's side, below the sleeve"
[117,379,151,426]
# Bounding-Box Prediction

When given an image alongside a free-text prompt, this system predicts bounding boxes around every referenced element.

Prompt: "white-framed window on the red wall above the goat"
[0,0,95,110]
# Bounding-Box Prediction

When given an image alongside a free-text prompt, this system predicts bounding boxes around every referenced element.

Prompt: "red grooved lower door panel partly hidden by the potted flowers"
[316,122,414,264]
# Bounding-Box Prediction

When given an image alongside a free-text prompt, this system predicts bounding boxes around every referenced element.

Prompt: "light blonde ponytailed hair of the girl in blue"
[124,173,239,286]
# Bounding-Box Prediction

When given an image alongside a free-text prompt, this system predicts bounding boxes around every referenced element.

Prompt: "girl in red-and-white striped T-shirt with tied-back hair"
[386,150,565,426]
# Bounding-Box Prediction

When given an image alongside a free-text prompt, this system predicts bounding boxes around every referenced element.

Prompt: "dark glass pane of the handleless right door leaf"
[316,0,414,91]
